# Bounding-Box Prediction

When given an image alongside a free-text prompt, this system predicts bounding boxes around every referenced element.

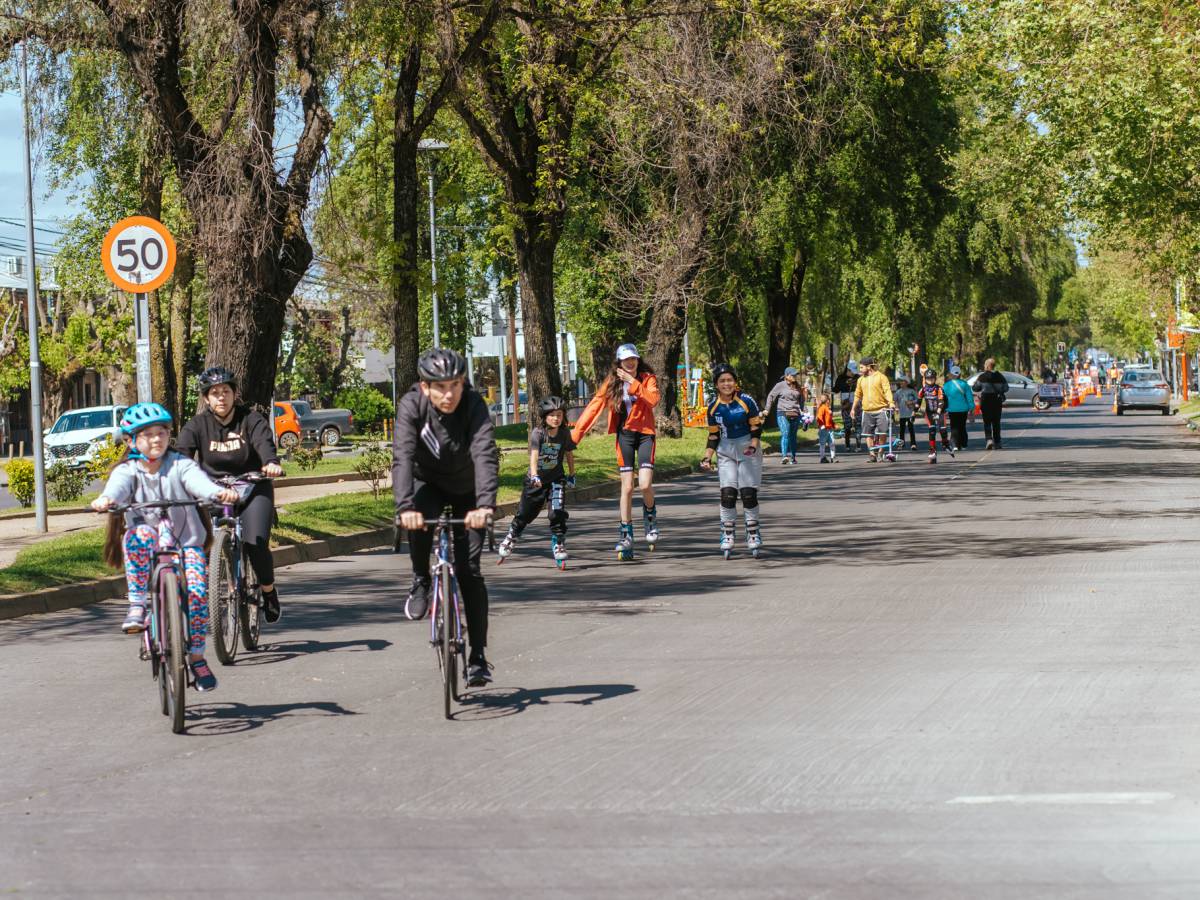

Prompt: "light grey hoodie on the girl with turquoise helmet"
[101,450,223,547]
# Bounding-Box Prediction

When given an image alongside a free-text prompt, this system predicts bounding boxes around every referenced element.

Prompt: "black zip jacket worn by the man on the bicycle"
[391,384,500,512]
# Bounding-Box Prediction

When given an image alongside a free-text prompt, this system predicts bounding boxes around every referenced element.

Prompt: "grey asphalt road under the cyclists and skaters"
[0,400,1200,899]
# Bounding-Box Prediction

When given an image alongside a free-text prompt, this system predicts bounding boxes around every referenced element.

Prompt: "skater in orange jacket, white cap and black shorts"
[571,343,659,560]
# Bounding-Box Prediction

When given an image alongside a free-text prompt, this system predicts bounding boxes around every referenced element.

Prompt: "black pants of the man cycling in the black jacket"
[408,481,487,653]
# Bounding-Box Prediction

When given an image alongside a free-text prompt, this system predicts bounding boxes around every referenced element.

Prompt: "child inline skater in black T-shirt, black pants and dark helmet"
[497,397,575,569]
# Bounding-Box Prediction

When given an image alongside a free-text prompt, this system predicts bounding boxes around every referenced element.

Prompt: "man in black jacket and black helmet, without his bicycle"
[391,348,499,688]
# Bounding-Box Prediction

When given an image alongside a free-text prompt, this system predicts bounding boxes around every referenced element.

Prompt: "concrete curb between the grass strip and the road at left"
[0,464,697,620]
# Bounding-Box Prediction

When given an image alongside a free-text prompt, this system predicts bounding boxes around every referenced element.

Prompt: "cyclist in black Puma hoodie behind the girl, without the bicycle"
[175,366,283,622]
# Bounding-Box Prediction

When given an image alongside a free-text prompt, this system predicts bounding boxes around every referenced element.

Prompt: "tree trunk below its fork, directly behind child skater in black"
[514,224,563,409]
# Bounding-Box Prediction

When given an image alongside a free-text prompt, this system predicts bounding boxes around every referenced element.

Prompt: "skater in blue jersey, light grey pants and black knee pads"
[700,362,762,559]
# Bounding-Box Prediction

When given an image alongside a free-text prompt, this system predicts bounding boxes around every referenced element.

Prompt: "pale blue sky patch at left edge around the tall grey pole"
[0,91,72,257]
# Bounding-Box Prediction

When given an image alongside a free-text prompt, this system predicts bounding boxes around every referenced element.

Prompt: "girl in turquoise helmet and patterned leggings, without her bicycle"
[91,403,238,691]
